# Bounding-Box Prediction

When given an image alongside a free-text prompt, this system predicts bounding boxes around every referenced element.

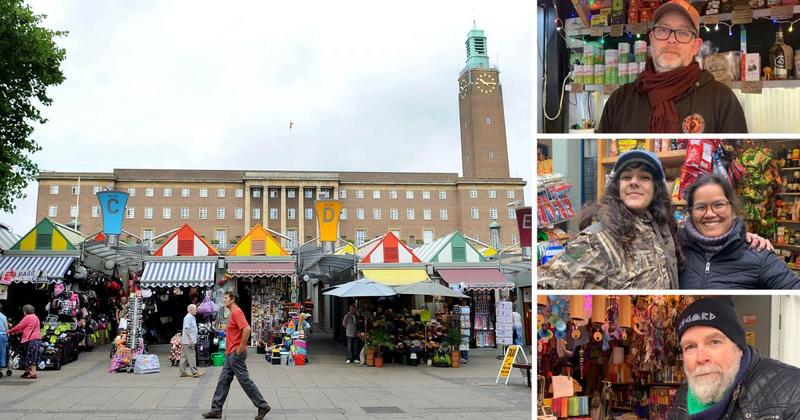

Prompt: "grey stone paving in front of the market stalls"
[0,333,532,420]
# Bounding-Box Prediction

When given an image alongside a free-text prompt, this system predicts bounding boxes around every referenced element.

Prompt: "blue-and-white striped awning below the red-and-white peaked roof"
[139,261,217,287]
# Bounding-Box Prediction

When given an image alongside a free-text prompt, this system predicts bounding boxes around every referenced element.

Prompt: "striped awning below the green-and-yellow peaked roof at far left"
[0,256,75,284]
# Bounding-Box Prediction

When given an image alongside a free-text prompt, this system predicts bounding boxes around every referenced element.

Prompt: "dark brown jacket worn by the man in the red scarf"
[597,70,747,133]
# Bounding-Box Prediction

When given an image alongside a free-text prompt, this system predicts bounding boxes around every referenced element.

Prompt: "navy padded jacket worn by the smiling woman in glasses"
[678,225,800,289]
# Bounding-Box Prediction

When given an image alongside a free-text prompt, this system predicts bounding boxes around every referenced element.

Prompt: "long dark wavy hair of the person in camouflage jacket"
[579,162,684,270]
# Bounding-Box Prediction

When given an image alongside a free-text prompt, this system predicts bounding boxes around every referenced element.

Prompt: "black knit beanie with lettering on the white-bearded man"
[678,296,747,351]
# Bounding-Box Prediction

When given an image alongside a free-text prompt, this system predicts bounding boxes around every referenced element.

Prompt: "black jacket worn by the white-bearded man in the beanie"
[668,347,800,420]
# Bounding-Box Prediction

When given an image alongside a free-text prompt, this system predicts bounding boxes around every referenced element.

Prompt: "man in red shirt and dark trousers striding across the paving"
[203,290,271,420]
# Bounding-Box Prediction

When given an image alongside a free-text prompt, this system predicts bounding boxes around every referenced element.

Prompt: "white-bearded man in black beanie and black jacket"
[669,297,800,420]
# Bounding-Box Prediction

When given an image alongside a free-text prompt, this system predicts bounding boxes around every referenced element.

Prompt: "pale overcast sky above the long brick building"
[0,0,534,234]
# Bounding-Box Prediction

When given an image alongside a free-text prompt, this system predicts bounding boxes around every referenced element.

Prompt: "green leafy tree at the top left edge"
[0,0,67,212]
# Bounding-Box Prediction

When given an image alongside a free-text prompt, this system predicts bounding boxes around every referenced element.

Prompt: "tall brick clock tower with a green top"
[458,24,509,178]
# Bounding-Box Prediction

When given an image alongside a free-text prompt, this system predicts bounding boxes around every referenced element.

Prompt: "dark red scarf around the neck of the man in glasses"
[636,59,701,133]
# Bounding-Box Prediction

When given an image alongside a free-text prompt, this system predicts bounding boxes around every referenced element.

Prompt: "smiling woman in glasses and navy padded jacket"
[679,175,800,289]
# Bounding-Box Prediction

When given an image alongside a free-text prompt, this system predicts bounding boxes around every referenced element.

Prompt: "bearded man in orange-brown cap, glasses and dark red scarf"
[598,0,747,133]
